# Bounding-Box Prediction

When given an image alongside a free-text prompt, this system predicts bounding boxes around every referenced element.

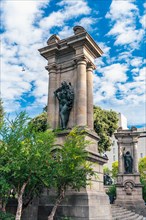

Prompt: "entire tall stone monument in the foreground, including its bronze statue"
[38,26,112,220]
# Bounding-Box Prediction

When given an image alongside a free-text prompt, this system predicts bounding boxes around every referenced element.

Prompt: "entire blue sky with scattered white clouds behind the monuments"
[1,0,146,127]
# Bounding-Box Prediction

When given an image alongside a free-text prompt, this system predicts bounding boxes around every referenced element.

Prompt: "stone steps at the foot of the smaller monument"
[111,205,146,220]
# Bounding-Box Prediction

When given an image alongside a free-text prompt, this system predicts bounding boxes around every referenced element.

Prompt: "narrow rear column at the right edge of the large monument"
[87,64,93,130]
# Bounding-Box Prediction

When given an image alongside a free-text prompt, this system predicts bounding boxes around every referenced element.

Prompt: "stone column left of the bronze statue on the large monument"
[46,64,56,129]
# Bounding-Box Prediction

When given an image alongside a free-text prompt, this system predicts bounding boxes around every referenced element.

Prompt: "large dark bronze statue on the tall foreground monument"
[54,81,74,129]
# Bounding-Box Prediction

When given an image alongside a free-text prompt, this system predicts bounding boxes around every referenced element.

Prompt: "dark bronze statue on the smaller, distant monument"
[123,151,133,173]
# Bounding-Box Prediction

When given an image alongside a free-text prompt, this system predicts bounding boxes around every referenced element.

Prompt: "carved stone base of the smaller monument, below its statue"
[115,173,146,217]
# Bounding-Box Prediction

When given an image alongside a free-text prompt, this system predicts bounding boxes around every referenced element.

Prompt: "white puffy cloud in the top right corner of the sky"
[106,0,144,49]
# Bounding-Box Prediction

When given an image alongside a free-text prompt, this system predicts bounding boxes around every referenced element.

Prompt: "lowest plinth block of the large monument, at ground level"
[38,191,112,220]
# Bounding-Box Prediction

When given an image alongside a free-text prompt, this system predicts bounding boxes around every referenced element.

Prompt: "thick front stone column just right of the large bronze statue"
[76,58,87,126]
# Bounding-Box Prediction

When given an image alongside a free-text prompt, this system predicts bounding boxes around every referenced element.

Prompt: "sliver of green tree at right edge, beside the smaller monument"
[138,157,146,202]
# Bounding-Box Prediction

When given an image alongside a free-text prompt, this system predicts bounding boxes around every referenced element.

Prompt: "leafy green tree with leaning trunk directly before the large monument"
[42,128,94,220]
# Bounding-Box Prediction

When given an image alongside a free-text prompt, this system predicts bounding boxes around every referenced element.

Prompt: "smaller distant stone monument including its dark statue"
[115,127,146,216]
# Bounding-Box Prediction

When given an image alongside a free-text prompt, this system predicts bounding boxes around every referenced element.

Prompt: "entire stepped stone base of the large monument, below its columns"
[38,129,112,220]
